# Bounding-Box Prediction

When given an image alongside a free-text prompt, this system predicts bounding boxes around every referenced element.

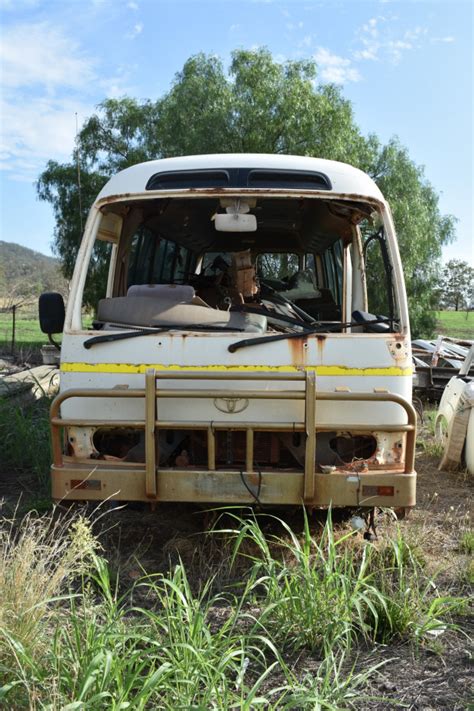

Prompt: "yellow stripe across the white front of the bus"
[61,363,413,377]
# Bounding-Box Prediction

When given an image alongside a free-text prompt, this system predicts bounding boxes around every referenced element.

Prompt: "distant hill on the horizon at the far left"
[0,241,67,305]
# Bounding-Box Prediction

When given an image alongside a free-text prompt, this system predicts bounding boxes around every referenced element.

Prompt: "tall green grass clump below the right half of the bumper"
[221,512,462,655]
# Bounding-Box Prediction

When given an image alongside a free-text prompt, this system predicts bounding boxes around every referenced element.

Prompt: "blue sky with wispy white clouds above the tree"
[0,0,474,264]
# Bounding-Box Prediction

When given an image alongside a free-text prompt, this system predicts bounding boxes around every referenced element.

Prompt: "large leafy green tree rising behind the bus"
[38,49,454,334]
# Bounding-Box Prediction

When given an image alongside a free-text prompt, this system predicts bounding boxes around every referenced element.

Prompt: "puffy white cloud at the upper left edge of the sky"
[0,22,95,91]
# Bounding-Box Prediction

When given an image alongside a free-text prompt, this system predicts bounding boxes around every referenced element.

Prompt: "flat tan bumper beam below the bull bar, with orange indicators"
[51,461,416,508]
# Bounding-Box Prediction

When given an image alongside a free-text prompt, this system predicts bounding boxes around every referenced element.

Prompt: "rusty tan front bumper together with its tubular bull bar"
[51,370,416,507]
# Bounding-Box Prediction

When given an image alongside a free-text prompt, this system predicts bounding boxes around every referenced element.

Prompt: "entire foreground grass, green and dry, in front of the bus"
[0,514,466,711]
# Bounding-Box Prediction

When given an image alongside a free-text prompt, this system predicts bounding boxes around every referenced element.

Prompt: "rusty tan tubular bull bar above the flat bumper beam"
[51,369,416,504]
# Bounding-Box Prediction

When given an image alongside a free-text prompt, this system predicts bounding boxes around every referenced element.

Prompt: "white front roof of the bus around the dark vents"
[97,153,384,201]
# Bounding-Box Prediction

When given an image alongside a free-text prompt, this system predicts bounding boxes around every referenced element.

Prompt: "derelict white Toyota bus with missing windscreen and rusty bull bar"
[40,154,416,508]
